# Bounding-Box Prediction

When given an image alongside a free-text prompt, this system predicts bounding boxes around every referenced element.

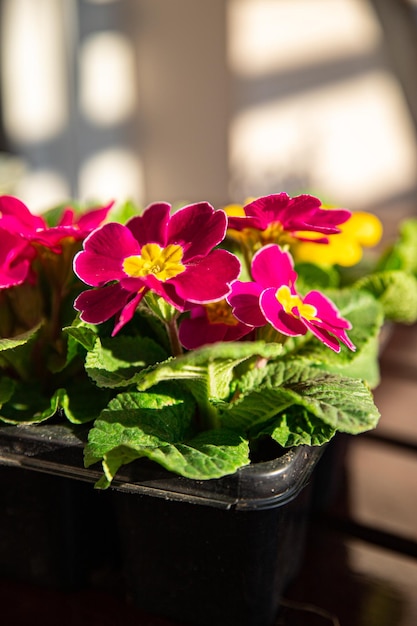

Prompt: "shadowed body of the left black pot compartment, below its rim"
[0,466,118,590]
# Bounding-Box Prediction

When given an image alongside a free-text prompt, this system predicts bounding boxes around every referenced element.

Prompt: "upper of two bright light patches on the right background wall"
[228,0,381,76]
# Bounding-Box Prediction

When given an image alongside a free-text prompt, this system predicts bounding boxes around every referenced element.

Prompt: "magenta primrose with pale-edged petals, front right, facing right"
[227,244,355,352]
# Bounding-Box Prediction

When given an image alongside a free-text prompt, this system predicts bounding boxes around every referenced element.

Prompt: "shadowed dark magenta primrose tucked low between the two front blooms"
[178,299,253,350]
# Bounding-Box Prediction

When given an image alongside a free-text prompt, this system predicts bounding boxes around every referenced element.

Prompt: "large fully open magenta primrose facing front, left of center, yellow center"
[74,202,240,335]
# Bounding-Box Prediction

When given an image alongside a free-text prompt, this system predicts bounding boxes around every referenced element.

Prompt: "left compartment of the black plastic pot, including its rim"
[0,426,119,590]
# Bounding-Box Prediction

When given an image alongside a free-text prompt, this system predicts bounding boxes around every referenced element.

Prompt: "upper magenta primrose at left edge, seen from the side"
[0,196,114,253]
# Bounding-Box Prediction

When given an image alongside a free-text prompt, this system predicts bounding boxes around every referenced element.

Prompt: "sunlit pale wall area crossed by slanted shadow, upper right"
[228,0,417,206]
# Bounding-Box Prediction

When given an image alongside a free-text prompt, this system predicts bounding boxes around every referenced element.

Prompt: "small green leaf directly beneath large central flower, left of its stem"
[85,335,167,388]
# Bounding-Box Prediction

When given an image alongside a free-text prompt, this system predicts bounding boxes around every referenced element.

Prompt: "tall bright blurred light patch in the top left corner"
[1,0,68,143]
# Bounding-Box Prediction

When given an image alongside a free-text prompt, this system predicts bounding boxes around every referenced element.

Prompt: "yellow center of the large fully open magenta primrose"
[123,243,185,282]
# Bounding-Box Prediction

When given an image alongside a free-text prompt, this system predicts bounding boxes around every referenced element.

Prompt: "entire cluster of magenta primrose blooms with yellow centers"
[0,193,355,352]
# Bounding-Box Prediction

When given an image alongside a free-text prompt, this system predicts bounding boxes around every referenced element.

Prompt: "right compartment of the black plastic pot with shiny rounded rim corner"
[115,448,318,626]
